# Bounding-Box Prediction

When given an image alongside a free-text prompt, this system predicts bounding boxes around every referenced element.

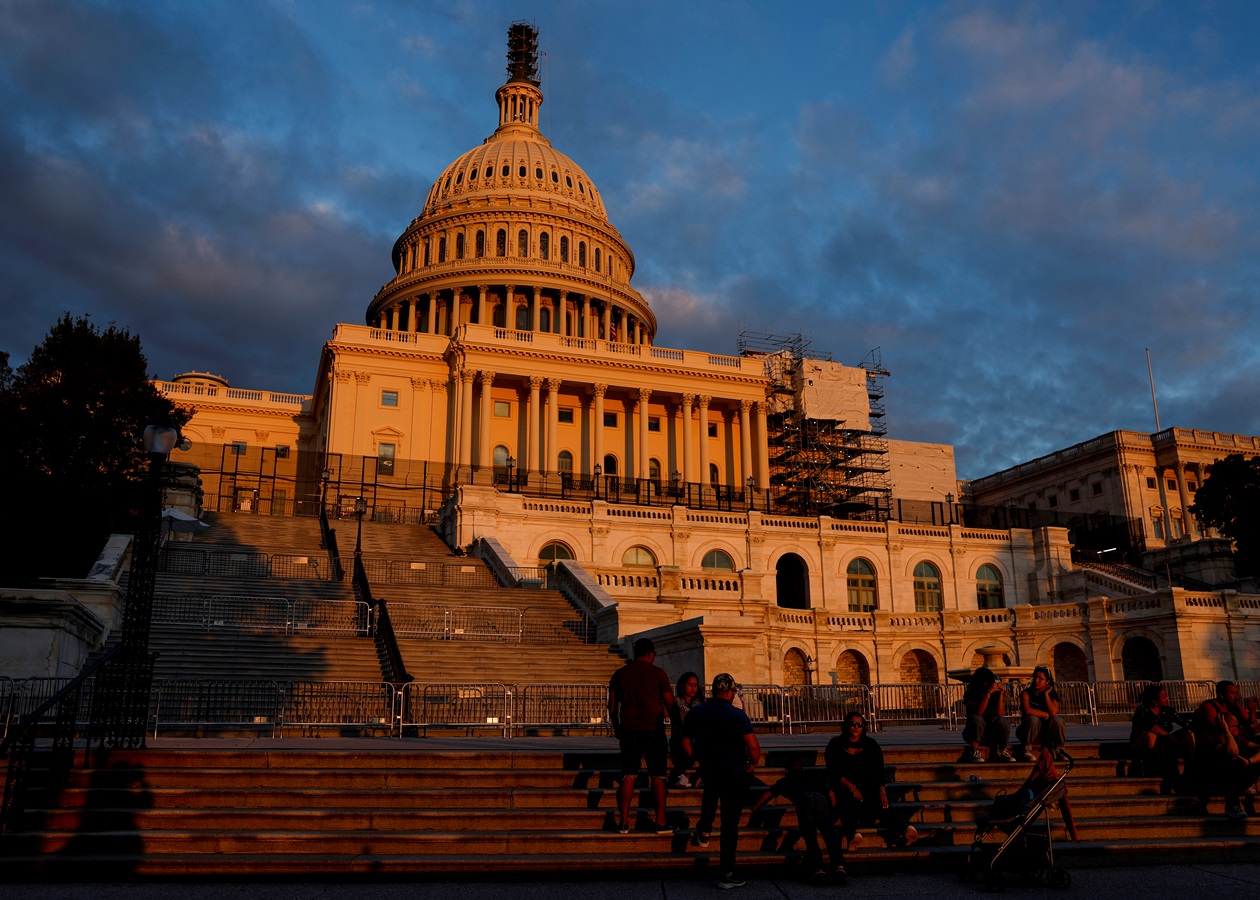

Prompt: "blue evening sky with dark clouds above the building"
[0,0,1260,478]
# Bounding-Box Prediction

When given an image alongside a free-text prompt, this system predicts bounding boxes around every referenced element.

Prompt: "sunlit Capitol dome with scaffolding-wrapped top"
[367,23,656,344]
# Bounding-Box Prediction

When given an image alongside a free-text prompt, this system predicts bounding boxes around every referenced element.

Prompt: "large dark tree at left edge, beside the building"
[0,314,188,584]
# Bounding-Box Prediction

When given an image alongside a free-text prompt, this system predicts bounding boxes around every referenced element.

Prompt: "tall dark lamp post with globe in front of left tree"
[89,425,180,747]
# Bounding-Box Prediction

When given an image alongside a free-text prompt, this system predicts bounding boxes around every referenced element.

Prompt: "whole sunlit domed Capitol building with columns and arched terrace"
[144,25,1260,684]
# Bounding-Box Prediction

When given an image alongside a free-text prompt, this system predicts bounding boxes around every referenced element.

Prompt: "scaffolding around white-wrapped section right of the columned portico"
[740,329,892,521]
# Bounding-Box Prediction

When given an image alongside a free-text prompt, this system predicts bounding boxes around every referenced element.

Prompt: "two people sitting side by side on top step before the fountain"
[959,666,1067,763]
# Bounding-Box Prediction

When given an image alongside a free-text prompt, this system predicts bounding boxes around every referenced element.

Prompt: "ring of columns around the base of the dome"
[375,284,653,344]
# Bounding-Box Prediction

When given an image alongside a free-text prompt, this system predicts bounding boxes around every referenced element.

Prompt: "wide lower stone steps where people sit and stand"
[4,736,1260,879]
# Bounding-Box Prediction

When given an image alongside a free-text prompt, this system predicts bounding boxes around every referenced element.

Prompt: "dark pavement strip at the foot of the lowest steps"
[0,863,1260,900]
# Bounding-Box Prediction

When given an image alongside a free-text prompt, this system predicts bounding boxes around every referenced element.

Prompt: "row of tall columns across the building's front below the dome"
[451,368,770,488]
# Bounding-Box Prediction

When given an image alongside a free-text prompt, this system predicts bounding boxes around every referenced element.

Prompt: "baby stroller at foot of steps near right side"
[963,749,1076,890]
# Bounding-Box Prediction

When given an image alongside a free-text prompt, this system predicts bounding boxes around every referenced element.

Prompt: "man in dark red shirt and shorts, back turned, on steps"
[609,638,674,834]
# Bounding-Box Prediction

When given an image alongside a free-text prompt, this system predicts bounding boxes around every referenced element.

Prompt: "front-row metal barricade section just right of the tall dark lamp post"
[152,678,285,737]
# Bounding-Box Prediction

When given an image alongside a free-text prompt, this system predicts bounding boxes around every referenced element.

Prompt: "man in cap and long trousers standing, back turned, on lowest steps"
[683,672,761,887]
